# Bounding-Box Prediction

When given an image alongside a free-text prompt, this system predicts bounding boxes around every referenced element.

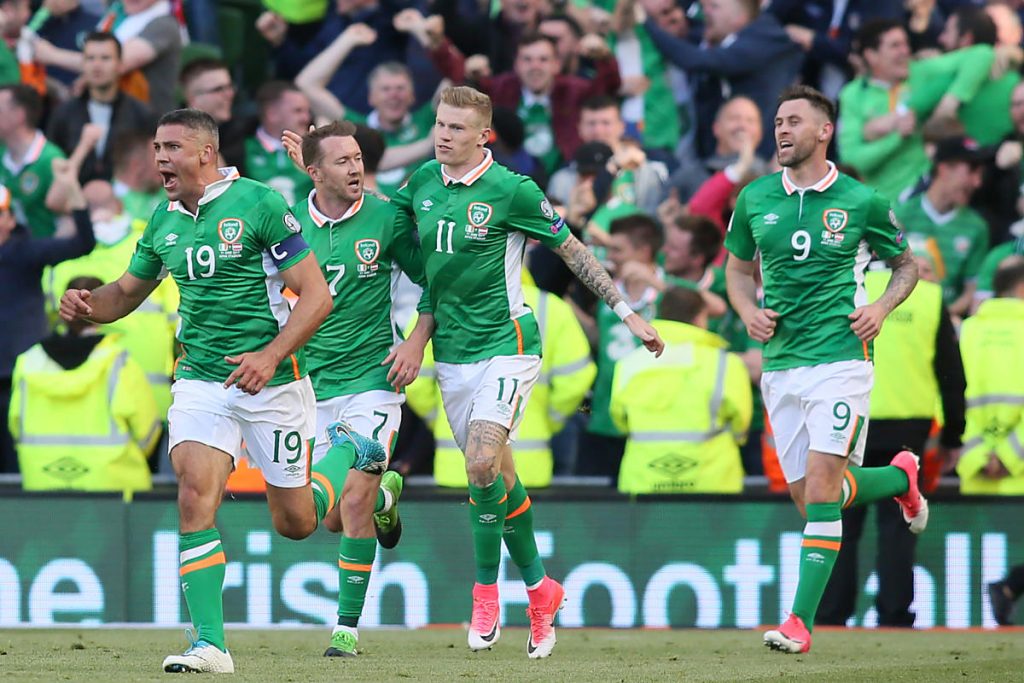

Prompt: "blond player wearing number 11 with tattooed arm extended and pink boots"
[393,86,665,658]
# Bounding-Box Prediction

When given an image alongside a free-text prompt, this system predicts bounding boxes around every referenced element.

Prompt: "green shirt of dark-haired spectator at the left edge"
[0,130,65,238]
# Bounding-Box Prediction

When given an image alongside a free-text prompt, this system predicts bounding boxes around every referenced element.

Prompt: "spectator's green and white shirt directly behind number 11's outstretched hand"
[587,285,660,436]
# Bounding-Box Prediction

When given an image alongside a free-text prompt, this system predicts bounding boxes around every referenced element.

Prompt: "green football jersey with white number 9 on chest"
[725,163,906,371]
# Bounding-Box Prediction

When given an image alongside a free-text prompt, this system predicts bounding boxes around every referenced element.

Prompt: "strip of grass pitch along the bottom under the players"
[0,628,1024,683]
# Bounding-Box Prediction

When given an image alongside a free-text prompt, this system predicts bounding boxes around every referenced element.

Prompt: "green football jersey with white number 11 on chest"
[394,151,570,362]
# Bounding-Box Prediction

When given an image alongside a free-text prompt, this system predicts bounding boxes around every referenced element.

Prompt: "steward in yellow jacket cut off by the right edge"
[956,261,1024,496]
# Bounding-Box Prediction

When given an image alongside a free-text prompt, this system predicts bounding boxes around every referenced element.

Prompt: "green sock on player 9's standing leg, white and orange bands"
[793,502,843,631]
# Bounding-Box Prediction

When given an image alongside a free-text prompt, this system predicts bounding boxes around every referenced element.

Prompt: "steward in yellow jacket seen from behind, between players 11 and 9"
[610,288,753,494]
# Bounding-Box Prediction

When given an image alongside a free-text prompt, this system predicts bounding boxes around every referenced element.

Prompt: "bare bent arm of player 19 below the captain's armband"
[224,252,331,394]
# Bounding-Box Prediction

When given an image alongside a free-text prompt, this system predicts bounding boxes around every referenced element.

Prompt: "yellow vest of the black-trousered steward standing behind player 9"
[864,270,942,420]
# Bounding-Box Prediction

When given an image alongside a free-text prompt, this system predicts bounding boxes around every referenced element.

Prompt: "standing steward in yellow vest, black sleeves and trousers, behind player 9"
[815,264,965,627]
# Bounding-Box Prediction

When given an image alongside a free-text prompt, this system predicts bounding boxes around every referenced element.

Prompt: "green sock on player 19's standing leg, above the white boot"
[178,528,226,651]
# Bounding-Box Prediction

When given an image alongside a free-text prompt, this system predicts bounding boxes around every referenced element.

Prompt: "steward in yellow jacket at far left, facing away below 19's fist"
[8,278,161,492]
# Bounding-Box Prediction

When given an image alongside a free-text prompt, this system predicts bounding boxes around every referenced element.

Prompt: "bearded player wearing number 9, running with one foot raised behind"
[725,86,928,653]
